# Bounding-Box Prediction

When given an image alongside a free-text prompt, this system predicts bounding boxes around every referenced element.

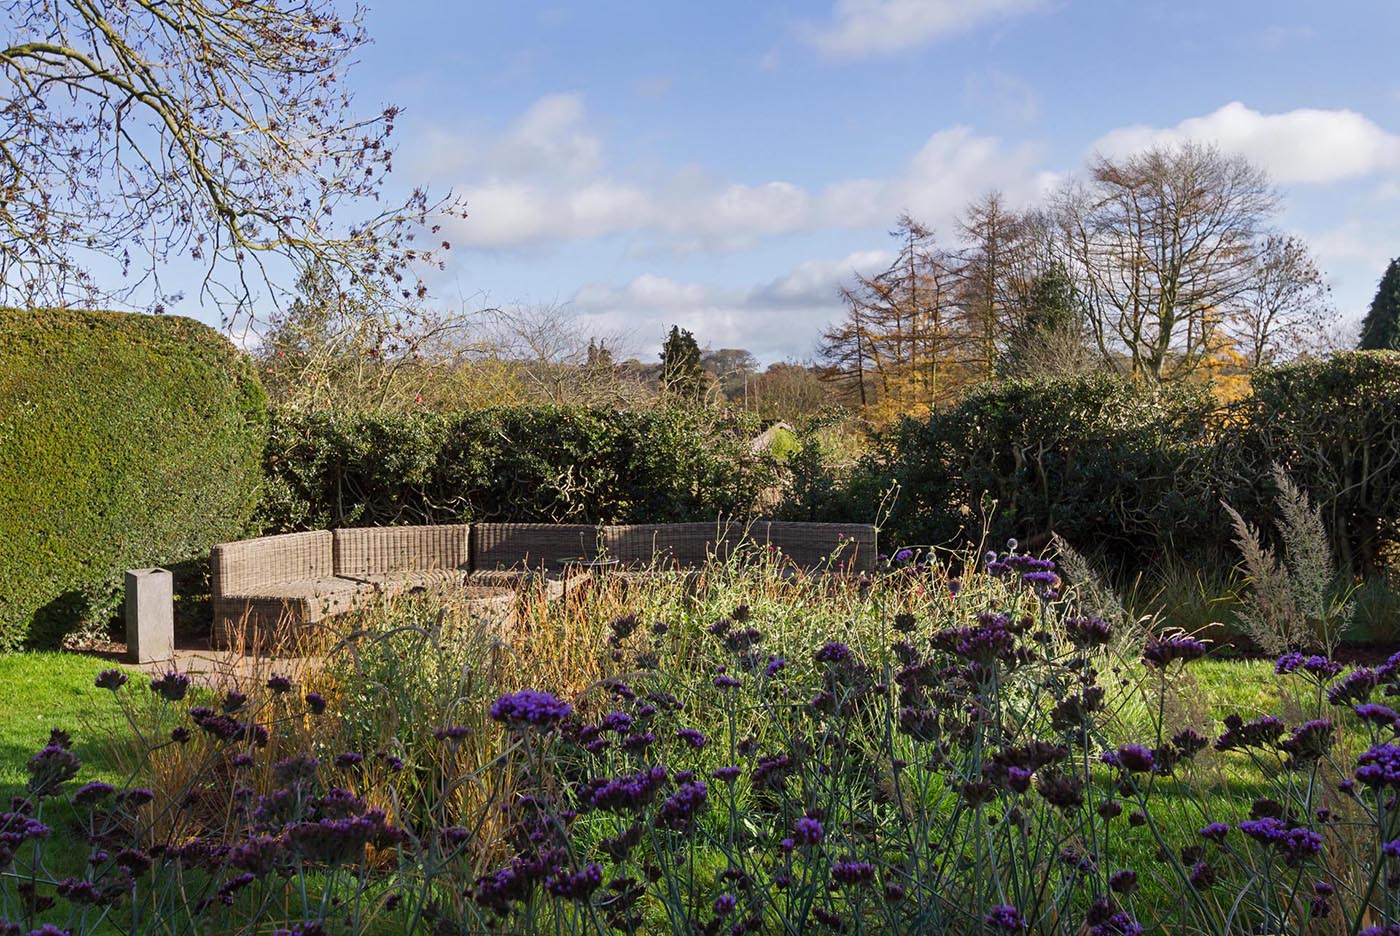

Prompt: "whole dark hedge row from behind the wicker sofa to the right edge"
[259,351,1400,572]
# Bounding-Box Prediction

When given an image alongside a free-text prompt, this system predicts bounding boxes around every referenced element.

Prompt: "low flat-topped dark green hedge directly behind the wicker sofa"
[259,407,774,532]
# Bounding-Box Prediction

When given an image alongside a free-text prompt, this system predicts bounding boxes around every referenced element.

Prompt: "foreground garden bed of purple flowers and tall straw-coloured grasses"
[0,557,1400,936]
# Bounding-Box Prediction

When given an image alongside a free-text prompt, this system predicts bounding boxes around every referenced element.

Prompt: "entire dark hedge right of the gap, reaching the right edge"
[823,351,1400,572]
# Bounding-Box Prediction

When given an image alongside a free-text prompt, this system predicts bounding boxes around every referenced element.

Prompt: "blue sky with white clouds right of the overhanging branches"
[238,0,1400,361]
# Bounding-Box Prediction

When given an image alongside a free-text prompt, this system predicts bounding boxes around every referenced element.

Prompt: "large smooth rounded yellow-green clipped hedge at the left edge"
[0,309,266,649]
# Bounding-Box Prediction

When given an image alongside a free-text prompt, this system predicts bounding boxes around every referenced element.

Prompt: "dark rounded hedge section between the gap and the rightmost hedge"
[853,376,1215,567]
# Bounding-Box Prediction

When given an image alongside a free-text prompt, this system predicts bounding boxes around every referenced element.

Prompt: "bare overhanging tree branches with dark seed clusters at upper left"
[0,0,456,323]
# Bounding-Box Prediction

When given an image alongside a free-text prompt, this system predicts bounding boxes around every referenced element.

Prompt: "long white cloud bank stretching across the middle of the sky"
[430,95,1051,252]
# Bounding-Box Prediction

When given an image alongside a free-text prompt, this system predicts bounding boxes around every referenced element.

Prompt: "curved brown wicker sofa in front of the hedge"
[210,520,876,644]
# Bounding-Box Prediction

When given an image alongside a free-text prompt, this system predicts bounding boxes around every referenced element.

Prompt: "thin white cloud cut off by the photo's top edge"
[802,0,1043,59]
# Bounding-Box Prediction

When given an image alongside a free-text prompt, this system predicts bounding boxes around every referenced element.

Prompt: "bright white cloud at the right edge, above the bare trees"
[1095,101,1400,183]
